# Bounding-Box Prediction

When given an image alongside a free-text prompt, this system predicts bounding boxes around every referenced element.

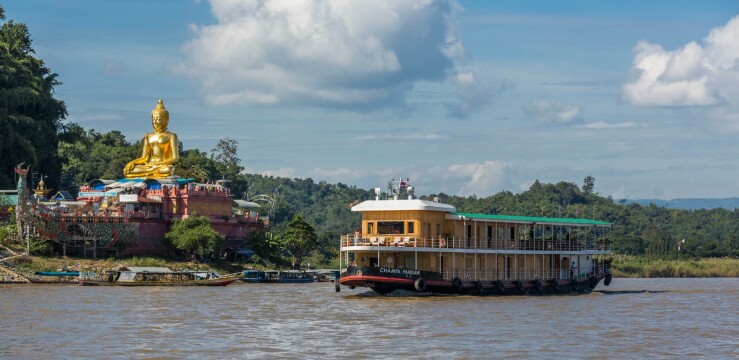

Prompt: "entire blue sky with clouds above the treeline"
[0,0,739,200]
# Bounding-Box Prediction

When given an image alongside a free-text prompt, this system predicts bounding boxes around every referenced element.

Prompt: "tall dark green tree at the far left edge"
[0,6,67,188]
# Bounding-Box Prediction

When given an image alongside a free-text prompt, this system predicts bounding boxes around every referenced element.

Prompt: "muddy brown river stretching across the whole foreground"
[0,278,739,359]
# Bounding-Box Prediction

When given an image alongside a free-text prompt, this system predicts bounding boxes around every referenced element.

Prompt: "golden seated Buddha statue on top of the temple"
[123,99,180,179]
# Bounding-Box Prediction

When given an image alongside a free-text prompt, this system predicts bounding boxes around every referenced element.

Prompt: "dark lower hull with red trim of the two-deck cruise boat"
[339,267,610,295]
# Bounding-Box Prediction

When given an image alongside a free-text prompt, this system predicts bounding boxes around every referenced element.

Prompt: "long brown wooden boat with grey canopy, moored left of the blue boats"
[79,268,243,286]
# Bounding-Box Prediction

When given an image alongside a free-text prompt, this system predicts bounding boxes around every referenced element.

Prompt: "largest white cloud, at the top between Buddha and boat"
[178,0,463,107]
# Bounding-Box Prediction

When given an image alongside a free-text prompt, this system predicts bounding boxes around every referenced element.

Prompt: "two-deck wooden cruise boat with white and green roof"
[336,180,612,295]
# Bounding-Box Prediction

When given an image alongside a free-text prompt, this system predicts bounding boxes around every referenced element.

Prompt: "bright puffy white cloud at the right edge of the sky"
[623,16,739,110]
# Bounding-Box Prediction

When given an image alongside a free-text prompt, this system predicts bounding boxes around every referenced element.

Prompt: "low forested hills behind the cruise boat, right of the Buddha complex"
[245,175,739,258]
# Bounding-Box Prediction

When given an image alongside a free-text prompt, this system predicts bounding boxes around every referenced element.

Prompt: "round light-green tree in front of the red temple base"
[164,215,225,257]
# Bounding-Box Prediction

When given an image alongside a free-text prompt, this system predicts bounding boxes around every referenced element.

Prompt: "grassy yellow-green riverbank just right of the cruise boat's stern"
[611,255,739,278]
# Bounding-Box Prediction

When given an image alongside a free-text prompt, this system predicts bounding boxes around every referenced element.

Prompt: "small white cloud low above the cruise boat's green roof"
[444,161,513,196]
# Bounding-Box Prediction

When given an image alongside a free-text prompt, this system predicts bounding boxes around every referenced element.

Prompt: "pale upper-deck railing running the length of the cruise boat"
[341,234,611,252]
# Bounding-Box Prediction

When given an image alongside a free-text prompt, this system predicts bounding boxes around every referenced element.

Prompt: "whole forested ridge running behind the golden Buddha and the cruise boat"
[26,119,739,258]
